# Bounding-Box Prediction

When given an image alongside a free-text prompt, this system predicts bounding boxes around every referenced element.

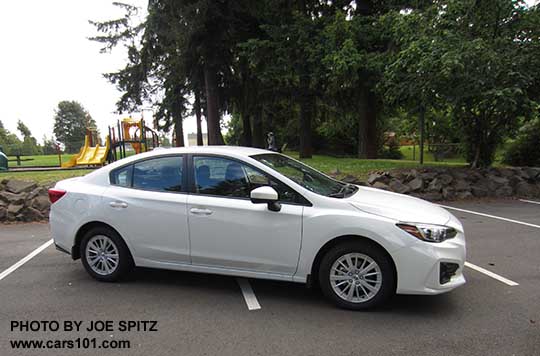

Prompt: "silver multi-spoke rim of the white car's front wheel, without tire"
[330,253,382,303]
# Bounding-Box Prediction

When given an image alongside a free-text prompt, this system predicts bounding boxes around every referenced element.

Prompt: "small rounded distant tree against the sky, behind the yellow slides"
[53,101,97,153]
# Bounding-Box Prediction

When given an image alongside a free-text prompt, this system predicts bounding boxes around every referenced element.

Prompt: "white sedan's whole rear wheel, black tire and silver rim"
[81,227,133,282]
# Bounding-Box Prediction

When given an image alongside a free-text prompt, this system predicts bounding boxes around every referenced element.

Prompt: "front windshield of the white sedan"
[251,153,358,198]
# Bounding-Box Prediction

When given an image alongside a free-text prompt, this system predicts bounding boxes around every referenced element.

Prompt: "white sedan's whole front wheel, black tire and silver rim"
[319,241,395,310]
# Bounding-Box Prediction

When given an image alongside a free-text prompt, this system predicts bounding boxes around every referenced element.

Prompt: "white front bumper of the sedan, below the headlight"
[392,232,466,294]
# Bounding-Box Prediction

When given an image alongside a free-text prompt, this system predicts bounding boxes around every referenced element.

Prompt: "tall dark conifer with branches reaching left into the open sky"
[91,0,262,144]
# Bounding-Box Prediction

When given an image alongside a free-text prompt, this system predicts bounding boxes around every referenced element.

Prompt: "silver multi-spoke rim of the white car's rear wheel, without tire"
[85,235,120,276]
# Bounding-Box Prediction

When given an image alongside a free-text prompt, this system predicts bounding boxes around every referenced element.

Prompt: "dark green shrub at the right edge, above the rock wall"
[503,118,540,166]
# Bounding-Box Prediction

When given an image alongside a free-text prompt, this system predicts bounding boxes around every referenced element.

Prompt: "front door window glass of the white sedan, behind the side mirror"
[193,156,298,203]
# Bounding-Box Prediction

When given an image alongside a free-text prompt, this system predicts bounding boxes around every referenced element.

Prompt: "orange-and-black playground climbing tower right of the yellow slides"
[107,117,159,163]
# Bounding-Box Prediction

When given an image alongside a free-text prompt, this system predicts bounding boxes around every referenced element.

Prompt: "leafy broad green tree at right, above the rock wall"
[381,0,538,167]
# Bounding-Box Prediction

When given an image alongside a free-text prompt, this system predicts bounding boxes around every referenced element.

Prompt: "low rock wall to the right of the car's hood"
[354,167,540,201]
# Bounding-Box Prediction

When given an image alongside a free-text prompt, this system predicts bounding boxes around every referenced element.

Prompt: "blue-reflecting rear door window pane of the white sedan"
[133,156,183,192]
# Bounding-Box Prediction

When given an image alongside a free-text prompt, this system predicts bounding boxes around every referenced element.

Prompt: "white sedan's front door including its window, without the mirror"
[187,156,303,275]
